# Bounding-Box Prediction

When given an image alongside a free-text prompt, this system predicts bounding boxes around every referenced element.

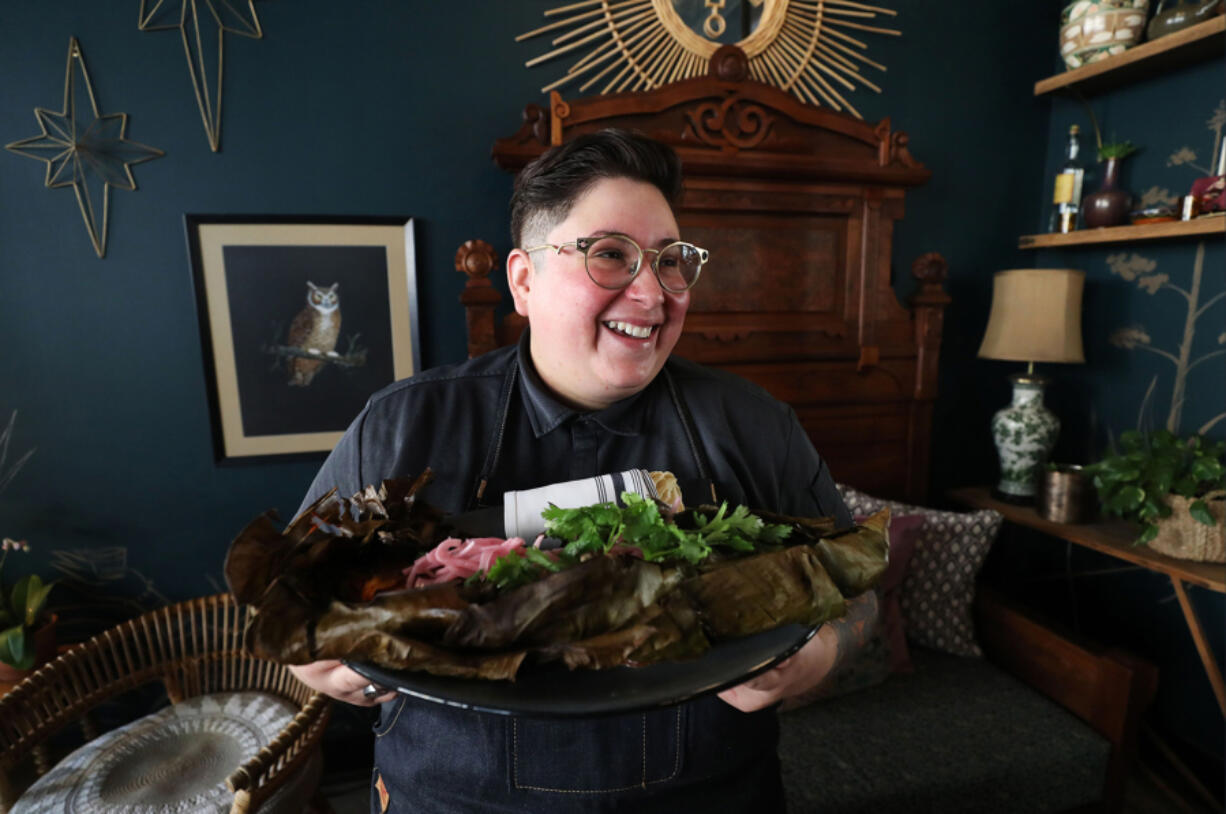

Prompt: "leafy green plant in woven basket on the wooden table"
[1086,429,1226,561]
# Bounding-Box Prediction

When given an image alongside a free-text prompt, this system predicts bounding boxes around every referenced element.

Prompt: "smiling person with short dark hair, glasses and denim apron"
[293,130,875,814]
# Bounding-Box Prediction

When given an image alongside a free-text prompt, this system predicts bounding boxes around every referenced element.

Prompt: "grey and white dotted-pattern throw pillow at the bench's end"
[839,485,1004,656]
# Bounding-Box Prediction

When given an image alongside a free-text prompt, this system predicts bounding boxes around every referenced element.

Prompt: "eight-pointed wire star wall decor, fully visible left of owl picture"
[5,37,164,257]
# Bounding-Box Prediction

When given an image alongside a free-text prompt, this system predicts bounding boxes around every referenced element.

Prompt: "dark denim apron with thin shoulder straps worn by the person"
[370,364,783,814]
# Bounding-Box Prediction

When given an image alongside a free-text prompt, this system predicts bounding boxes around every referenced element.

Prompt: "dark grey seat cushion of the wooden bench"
[779,647,1111,814]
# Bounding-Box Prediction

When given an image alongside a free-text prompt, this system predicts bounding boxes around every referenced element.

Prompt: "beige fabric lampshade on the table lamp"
[980,268,1085,362]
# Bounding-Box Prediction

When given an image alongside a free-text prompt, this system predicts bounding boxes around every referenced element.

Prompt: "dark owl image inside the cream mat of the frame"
[213,245,396,446]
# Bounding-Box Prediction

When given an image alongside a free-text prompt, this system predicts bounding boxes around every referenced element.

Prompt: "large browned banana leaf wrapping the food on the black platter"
[226,471,888,680]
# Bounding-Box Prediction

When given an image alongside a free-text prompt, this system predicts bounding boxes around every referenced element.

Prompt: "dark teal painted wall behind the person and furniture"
[0,0,1224,774]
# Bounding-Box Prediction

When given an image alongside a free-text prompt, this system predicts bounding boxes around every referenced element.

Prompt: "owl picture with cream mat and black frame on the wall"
[184,215,421,462]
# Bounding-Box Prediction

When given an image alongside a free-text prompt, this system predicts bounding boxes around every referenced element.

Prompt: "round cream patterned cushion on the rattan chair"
[12,691,318,814]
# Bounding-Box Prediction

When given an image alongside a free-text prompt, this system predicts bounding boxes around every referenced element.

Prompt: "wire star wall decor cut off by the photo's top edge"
[137,0,264,152]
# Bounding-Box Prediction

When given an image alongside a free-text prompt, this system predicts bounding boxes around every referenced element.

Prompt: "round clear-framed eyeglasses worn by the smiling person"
[524,234,709,294]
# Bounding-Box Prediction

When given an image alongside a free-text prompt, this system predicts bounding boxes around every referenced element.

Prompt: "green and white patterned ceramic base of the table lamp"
[992,374,1060,503]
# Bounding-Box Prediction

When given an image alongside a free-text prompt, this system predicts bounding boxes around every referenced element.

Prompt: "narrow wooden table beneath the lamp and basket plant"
[949,487,1226,716]
